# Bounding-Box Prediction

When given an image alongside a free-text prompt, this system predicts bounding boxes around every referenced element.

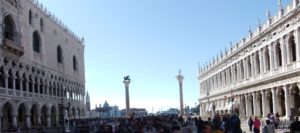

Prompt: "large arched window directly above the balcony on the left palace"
[4,16,15,41]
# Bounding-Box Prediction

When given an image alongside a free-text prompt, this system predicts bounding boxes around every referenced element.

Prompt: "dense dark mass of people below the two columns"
[70,114,242,133]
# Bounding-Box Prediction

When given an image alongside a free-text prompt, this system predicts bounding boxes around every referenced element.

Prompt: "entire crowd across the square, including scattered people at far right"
[70,113,300,133]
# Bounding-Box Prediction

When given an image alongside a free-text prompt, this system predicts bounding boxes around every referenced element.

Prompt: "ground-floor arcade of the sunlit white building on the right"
[201,83,300,118]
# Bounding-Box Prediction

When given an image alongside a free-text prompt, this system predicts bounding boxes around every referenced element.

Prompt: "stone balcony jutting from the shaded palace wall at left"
[1,39,24,57]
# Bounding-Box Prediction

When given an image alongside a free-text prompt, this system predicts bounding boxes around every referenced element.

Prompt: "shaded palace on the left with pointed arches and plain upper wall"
[0,0,86,129]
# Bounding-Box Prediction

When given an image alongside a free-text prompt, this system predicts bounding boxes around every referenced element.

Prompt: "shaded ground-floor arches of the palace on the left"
[0,101,84,129]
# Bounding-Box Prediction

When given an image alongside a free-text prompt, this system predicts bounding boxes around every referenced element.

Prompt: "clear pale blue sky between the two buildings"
[39,0,292,113]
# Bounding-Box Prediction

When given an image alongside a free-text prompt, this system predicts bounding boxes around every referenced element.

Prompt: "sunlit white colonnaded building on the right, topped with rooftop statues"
[199,0,300,118]
